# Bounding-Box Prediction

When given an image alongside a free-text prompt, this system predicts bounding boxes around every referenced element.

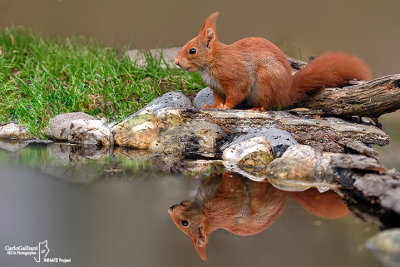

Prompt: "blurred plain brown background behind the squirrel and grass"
[0,0,400,168]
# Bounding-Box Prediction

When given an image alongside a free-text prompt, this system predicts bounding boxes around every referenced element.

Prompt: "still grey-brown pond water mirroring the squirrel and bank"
[0,144,381,267]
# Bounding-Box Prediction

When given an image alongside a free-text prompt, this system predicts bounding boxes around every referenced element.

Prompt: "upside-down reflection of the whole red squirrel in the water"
[168,172,348,260]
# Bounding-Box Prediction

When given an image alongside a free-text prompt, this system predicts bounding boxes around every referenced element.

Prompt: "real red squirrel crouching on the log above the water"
[175,12,371,110]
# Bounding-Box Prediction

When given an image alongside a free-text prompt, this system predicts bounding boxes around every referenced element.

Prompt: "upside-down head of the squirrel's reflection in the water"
[168,201,210,260]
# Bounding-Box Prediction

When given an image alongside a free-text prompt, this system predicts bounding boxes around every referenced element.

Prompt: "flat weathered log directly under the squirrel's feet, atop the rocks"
[192,109,389,154]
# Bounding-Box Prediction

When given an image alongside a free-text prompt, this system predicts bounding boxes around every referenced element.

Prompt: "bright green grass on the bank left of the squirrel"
[0,27,204,138]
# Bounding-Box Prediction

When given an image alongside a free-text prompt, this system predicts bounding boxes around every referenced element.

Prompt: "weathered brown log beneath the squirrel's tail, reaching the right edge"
[297,74,400,118]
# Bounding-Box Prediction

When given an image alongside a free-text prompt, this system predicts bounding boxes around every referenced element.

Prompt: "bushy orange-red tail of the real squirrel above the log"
[293,52,371,97]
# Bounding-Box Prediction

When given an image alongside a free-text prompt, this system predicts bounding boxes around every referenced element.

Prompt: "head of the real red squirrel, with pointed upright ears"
[175,12,218,72]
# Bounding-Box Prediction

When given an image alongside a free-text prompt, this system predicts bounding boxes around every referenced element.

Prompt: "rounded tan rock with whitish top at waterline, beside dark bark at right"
[266,145,337,192]
